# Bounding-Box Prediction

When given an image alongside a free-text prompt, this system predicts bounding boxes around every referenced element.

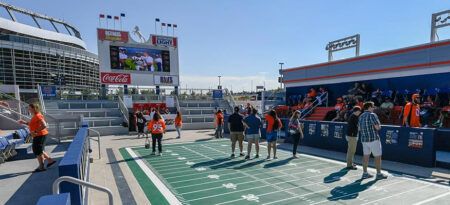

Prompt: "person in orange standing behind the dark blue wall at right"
[403,94,420,127]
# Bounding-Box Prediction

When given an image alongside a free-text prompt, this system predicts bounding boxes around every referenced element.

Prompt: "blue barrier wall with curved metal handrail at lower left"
[37,121,113,205]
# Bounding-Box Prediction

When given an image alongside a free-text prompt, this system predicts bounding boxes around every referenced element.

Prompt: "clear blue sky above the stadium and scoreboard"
[4,0,450,90]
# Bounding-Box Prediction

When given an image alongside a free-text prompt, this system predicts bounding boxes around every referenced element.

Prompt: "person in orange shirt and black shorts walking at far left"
[19,103,56,172]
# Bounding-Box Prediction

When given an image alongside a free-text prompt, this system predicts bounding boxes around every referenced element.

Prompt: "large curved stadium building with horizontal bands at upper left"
[0,2,100,92]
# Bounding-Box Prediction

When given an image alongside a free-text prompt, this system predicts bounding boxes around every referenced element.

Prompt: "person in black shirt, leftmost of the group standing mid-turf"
[228,106,245,158]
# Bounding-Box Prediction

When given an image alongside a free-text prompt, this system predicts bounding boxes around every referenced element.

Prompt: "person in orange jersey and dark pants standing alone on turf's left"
[147,112,166,156]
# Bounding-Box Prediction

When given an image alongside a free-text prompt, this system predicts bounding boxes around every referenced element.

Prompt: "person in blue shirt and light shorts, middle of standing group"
[244,108,262,159]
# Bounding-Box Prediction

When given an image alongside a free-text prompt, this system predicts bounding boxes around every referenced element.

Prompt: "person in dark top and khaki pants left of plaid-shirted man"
[345,106,361,170]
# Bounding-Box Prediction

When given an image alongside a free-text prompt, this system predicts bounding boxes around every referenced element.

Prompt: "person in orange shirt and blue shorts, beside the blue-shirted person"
[265,110,283,160]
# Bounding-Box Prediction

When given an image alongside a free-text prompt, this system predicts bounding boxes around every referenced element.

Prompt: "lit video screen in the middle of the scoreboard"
[110,46,170,72]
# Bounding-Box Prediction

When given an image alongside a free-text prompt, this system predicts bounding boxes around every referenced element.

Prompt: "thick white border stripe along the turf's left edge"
[126,148,181,205]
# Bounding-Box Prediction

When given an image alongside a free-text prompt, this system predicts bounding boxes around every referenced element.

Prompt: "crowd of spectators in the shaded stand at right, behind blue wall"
[285,83,450,127]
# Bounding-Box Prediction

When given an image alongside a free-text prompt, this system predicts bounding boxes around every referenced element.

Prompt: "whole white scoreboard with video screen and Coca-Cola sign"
[97,28,180,90]
